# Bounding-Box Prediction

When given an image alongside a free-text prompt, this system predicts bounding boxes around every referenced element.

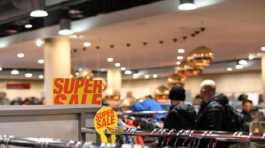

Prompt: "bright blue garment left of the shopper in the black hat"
[131,98,166,121]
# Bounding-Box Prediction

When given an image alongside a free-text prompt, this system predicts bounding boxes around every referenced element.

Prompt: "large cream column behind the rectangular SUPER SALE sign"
[44,37,71,105]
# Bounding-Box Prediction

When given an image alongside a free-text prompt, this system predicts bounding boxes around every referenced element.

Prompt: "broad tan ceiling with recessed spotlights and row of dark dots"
[0,0,265,75]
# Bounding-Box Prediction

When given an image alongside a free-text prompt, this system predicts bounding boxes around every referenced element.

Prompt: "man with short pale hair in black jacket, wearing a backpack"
[196,80,243,148]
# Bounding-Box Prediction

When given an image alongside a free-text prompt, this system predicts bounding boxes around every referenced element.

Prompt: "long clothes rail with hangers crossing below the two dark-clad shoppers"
[81,128,265,142]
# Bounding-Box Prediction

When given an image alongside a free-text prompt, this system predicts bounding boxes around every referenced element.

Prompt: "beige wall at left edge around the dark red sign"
[0,80,43,99]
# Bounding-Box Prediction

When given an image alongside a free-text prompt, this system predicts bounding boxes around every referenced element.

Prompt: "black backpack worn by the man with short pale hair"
[213,94,244,132]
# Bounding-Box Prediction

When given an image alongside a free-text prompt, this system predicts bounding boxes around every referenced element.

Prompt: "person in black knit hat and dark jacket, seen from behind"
[164,86,196,145]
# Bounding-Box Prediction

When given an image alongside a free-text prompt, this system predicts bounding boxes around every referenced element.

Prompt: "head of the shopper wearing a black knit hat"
[168,86,186,105]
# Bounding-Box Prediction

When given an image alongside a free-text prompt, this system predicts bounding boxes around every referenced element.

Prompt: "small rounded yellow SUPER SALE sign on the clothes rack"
[94,107,118,144]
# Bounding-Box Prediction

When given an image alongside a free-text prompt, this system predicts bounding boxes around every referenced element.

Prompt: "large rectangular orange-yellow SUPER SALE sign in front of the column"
[53,78,103,104]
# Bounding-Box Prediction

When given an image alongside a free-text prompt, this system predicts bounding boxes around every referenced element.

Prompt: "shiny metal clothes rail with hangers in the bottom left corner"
[0,135,92,148]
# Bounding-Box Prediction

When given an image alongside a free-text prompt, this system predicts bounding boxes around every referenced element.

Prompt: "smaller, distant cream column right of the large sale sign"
[107,68,122,93]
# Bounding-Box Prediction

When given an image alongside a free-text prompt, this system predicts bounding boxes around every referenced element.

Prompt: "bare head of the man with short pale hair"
[200,80,216,102]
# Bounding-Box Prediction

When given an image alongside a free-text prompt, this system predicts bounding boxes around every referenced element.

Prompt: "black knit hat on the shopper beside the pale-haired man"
[168,86,186,101]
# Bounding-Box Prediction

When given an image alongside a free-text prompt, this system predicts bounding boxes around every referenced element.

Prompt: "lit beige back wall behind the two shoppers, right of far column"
[122,71,262,97]
